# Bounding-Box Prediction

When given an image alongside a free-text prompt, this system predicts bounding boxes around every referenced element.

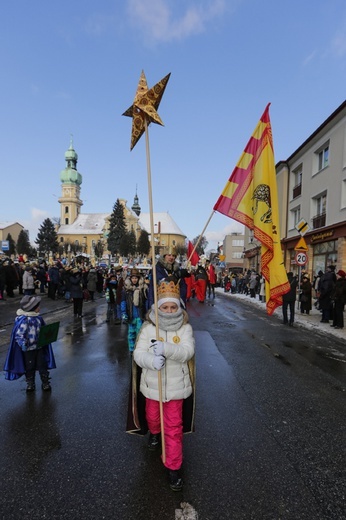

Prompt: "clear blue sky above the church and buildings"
[0,0,346,252]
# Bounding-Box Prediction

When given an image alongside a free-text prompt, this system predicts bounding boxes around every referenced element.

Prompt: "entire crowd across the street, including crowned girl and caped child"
[0,253,346,491]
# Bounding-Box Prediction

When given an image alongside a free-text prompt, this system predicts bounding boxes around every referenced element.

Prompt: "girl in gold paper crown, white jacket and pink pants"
[134,280,195,491]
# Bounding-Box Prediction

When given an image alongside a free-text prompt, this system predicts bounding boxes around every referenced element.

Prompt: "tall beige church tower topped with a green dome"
[58,138,83,226]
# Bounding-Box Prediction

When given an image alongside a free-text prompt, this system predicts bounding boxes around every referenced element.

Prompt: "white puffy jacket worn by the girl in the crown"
[133,322,195,402]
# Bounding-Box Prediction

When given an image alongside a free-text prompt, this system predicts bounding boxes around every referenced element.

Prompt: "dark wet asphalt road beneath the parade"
[0,294,346,520]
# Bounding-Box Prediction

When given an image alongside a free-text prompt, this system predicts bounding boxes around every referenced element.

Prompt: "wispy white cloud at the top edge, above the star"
[128,0,226,42]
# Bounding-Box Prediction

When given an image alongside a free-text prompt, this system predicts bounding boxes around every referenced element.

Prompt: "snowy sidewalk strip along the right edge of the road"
[215,287,346,339]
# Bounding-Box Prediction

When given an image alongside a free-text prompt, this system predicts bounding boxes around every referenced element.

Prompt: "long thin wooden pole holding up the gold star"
[144,114,166,463]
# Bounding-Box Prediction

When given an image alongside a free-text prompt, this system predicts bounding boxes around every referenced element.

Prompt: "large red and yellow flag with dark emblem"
[214,103,290,315]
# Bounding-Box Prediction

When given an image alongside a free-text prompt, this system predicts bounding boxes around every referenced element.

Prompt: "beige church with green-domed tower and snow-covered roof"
[57,141,186,261]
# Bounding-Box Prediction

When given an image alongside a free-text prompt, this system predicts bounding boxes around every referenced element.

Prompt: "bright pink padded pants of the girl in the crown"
[145,398,183,470]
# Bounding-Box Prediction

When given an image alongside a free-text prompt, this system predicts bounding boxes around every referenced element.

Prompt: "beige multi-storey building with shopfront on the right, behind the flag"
[276,101,346,277]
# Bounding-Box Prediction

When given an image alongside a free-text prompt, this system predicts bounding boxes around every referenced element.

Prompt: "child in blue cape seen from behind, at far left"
[4,295,56,392]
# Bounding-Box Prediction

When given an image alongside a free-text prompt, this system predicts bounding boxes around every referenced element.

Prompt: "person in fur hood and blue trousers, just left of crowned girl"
[121,269,146,352]
